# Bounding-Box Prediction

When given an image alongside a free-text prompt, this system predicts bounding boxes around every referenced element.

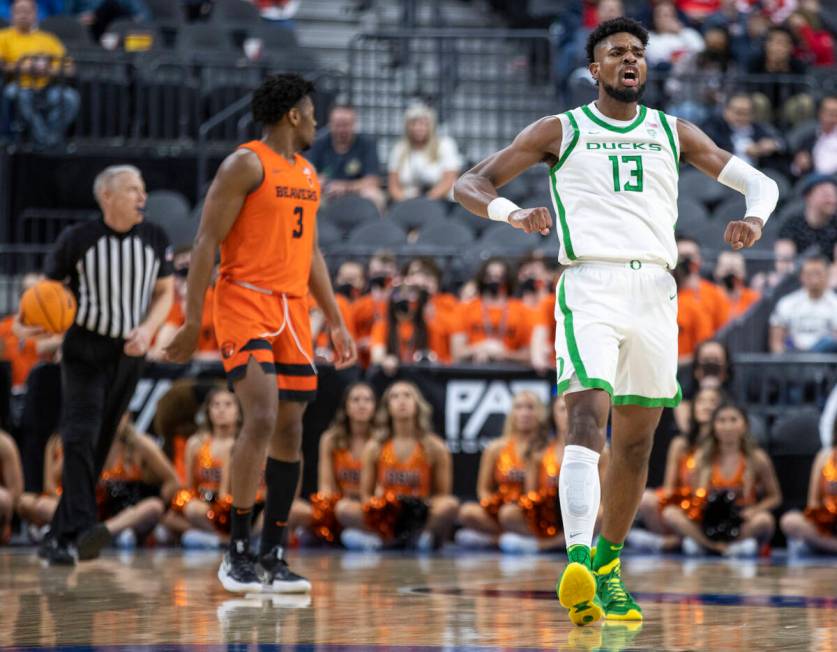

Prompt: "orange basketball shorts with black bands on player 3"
[214,279,317,402]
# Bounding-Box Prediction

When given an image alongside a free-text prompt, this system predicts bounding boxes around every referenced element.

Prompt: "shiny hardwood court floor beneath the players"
[0,549,837,652]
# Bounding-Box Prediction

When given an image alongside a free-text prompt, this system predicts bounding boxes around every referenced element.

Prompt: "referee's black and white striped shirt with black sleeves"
[46,219,172,338]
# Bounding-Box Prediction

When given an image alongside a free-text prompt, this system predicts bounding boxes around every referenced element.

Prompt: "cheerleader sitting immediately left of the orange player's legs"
[165,387,242,548]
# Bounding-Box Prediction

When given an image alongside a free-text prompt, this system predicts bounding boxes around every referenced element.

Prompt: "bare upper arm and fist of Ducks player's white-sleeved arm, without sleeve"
[677,118,764,249]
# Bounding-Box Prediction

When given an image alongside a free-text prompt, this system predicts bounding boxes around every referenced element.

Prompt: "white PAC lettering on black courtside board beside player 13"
[445,380,550,453]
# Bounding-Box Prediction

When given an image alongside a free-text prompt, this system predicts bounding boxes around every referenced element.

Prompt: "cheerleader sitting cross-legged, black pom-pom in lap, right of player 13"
[663,403,782,557]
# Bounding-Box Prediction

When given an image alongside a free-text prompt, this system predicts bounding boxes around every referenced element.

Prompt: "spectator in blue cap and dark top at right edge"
[779,174,837,260]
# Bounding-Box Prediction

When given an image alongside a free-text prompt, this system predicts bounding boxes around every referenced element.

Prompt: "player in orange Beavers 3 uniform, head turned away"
[166,74,357,593]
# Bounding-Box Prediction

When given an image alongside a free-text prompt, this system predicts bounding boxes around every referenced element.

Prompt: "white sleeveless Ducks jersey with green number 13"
[549,103,680,268]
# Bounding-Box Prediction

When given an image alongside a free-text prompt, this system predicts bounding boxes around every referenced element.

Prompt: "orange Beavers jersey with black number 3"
[220,140,320,297]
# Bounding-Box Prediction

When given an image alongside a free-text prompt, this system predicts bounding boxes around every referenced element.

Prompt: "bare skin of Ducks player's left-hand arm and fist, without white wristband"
[453,116,563,233]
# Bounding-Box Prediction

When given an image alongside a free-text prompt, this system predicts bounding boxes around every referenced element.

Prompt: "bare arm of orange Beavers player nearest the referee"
[165,149,264,362]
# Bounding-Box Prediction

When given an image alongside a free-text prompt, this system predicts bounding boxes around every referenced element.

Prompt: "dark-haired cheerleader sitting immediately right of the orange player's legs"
[289,382,377,543]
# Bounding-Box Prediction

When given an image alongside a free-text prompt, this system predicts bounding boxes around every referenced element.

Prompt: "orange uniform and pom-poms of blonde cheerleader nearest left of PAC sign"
[363,439,432,540]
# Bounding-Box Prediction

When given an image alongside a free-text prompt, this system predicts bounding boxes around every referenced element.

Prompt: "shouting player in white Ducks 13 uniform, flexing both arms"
[454,18,779,625]
